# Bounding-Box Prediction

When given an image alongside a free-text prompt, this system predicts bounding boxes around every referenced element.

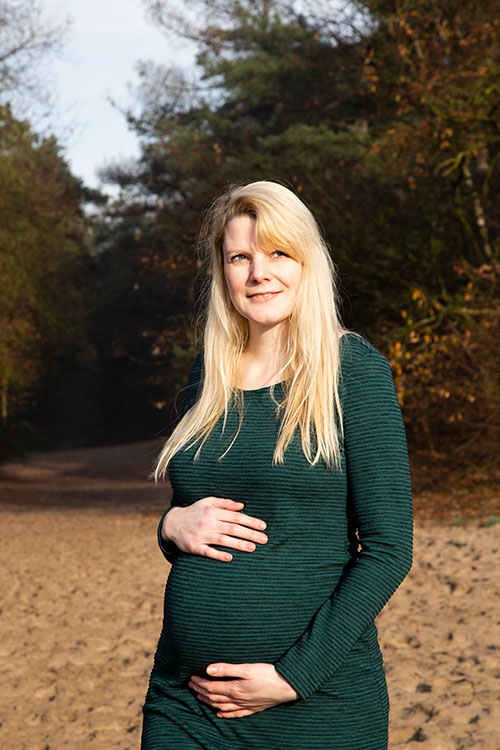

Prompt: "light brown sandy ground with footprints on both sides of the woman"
[0,443,500,750]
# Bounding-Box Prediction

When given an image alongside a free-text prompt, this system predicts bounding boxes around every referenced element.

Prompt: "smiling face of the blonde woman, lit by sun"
[223,216,302,330]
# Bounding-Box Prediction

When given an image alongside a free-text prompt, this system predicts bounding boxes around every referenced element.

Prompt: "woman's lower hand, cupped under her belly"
[189,663,299,719]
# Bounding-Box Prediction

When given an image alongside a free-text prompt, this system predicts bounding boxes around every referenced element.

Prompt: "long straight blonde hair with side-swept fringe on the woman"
[154,181,345,479]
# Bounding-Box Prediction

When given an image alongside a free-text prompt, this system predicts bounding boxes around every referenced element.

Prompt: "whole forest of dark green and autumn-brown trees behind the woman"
[0,0,500,516]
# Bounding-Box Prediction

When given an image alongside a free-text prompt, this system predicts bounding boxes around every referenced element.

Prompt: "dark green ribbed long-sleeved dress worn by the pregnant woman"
[142,334,412,750]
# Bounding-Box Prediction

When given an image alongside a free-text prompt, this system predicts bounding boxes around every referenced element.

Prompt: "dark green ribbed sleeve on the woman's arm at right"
[275,334,412,698]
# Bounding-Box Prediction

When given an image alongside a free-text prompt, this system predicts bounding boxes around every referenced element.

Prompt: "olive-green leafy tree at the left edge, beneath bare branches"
[0,109,89,444]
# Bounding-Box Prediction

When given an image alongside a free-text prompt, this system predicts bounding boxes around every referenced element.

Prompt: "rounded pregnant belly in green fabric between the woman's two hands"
[160,549,341,678]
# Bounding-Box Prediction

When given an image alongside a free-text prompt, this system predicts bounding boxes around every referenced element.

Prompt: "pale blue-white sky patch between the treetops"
[40,0,193,192]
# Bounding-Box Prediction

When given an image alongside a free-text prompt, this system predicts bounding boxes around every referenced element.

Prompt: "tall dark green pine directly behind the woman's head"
[103,2,399,344]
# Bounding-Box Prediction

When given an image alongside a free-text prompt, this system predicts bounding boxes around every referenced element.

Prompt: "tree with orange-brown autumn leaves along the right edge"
[352,0,500,461]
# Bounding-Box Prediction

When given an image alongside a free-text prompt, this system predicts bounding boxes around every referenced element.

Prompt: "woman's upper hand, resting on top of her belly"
[161,497,267,562]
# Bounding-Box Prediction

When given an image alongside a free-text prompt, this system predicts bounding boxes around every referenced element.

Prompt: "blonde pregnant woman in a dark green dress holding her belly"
[142,182,412,750]
